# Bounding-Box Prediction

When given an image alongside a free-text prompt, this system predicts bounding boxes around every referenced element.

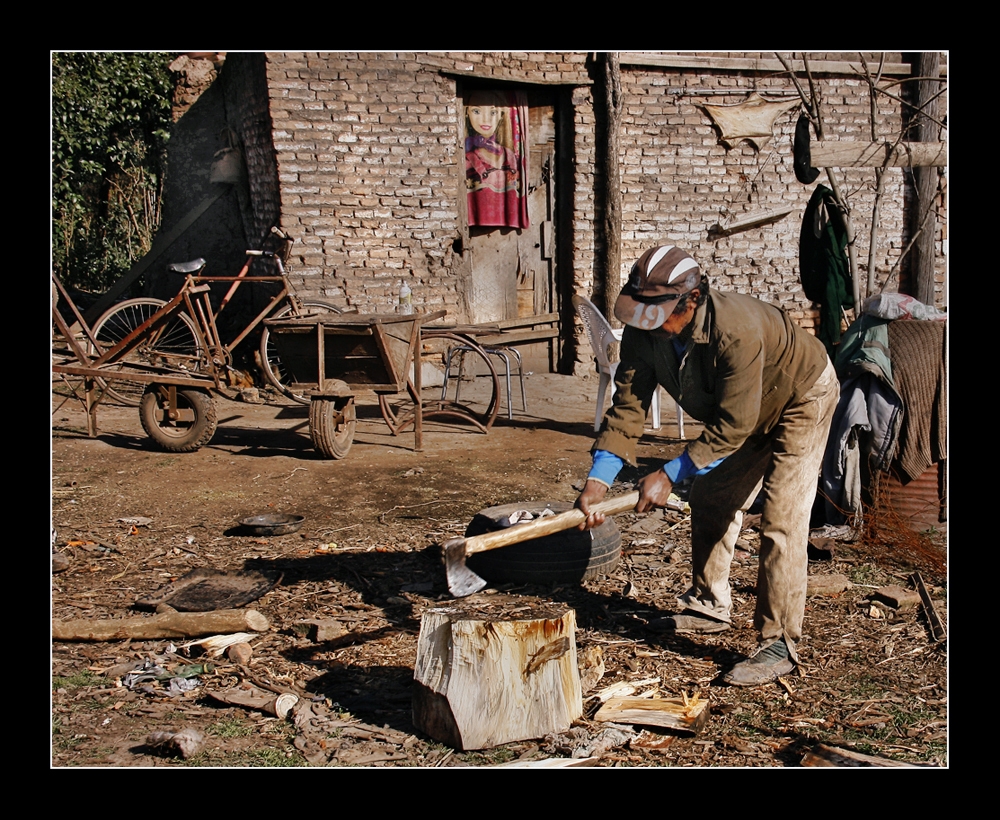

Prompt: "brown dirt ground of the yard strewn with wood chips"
[51,373,948,767]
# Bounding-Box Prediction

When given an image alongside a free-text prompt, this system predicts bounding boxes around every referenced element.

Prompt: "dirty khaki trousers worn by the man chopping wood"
[677,363,840,660]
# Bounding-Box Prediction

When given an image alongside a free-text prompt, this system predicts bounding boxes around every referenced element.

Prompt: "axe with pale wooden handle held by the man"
[444,490,639,598]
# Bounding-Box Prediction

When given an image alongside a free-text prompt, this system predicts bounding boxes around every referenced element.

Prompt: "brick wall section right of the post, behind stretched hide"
[622,55,903,327]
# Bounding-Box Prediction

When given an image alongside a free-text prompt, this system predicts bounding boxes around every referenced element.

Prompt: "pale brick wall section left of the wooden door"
[267,53,458,312]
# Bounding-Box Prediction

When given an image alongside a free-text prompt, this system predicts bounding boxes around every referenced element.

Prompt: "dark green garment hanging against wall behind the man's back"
[799,185,854,360]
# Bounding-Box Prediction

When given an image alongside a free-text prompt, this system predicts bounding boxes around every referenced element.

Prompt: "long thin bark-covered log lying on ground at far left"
[52,609,270,641]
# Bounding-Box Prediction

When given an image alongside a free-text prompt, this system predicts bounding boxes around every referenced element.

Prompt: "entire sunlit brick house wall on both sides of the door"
[248,52,945,366]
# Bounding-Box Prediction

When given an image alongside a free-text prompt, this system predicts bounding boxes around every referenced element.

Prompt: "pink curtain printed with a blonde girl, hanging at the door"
[465,91,528,228]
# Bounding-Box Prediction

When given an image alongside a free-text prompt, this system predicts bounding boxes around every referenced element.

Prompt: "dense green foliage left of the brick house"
[51,51,174,292]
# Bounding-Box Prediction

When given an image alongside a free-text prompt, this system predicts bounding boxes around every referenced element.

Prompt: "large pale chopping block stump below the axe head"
[413,596,583,750]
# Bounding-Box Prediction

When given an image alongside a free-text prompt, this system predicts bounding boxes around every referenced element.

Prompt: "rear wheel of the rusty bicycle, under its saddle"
[91,297,202,407]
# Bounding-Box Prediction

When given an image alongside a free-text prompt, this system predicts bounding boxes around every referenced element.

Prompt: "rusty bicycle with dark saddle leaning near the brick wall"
[90,227,342,407]
